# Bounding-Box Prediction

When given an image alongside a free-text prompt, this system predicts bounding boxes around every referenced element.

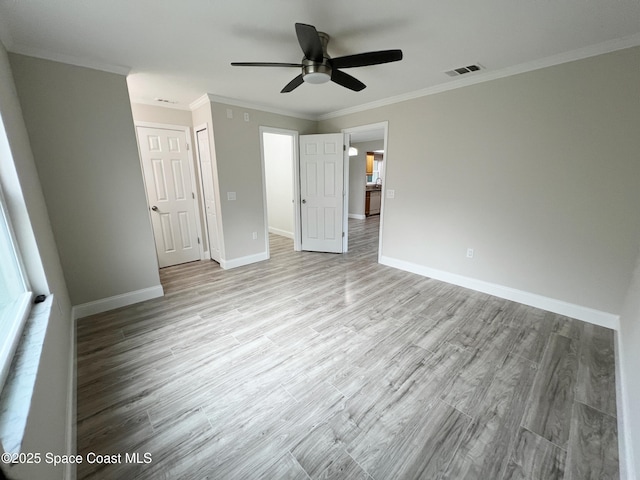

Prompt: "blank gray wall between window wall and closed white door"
[10,54,160,305]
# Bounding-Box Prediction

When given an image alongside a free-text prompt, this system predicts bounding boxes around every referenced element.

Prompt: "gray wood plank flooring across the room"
[77,217,619,480]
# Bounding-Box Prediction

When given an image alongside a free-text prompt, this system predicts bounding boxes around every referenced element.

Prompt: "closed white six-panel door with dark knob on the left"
[137,127,200,268]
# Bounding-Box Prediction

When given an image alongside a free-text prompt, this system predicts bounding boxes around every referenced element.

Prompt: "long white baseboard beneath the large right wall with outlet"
[380,255,620,331]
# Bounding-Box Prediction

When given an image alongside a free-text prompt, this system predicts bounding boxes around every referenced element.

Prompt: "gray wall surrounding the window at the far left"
[0,44,74,479]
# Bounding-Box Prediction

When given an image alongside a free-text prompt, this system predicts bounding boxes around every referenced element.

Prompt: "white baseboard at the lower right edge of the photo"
[613,330,636,480]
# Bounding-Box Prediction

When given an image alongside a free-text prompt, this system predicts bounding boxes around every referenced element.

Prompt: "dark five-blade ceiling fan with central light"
[231,23,402,93]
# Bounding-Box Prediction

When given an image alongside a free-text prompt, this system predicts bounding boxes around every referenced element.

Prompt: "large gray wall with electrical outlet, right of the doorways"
[320,48,640,314]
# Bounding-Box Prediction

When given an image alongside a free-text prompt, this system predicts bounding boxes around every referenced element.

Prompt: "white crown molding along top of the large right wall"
[317,33,640,121]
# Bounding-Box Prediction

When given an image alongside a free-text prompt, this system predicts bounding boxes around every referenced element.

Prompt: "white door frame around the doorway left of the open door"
[260,125,302,258]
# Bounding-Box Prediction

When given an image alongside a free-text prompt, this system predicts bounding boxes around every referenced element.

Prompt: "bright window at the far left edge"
[0,142,31,390]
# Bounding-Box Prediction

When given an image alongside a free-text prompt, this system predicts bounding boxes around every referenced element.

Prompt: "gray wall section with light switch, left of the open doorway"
[211,102,317,261]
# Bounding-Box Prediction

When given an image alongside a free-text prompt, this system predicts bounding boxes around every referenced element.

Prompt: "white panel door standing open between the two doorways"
[300,133,344,253]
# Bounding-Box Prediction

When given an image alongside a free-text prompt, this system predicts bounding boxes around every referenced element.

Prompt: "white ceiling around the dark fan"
[0,0,640,118]
